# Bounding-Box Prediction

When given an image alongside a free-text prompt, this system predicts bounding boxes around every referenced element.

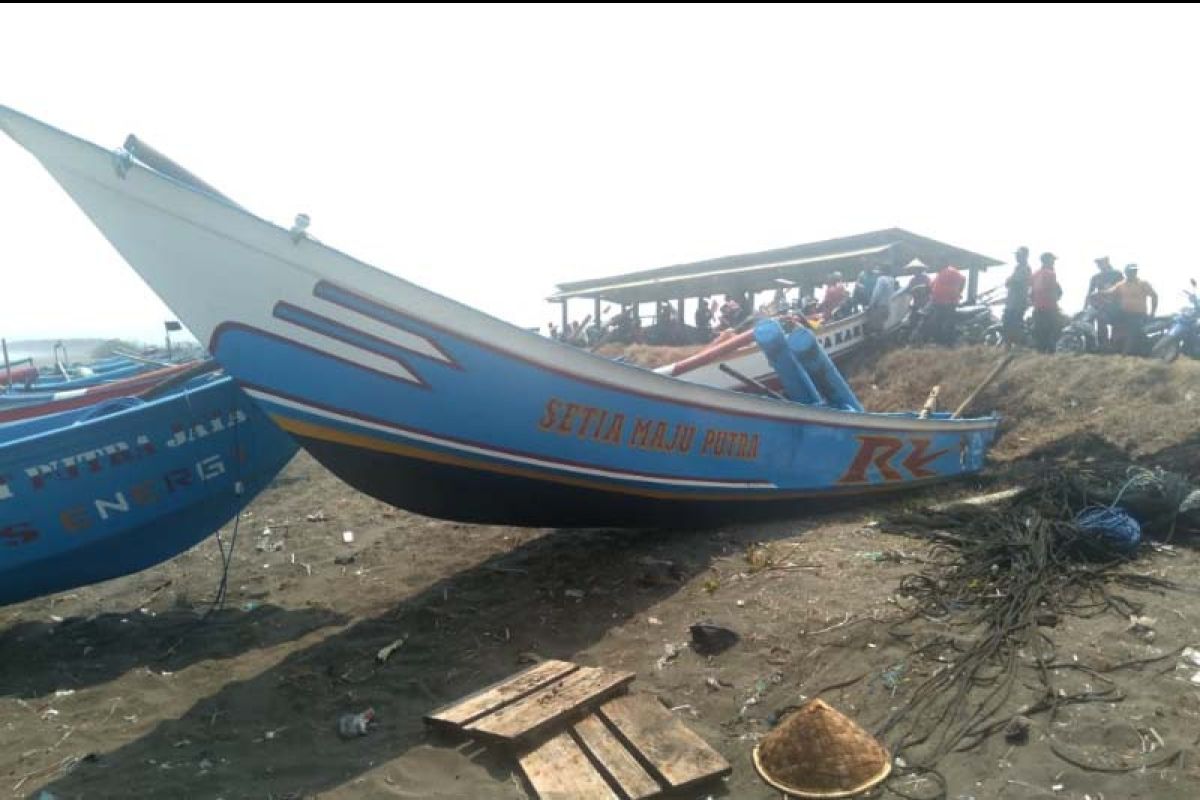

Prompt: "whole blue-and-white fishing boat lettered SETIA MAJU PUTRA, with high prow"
[0,107,997,527]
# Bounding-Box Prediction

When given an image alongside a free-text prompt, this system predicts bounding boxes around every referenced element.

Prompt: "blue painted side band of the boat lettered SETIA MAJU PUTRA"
[211,283,991,510]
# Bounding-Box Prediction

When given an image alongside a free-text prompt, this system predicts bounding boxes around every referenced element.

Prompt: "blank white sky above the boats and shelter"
[0,5,1200,341]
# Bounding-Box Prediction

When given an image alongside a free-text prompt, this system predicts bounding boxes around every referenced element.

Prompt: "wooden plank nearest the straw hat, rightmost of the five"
[600,694,732,789]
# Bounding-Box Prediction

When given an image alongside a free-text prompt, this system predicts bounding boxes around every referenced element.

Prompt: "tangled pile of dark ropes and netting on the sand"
[877,467,1200,796]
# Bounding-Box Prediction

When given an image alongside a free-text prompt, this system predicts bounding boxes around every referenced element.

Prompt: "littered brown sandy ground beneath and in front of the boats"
[0,352,1200,800]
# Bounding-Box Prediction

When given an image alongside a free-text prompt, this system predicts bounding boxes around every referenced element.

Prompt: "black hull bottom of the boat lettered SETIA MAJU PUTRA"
[298,437,907,528]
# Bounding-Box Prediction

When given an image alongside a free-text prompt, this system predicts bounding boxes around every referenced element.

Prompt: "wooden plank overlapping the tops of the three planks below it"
[467,667,634,741]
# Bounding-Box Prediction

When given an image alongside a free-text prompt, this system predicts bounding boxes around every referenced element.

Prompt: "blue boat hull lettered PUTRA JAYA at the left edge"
[0,377,296,603]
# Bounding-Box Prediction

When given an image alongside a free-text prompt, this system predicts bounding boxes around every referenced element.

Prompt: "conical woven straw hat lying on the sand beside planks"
[754,700,892,799]
